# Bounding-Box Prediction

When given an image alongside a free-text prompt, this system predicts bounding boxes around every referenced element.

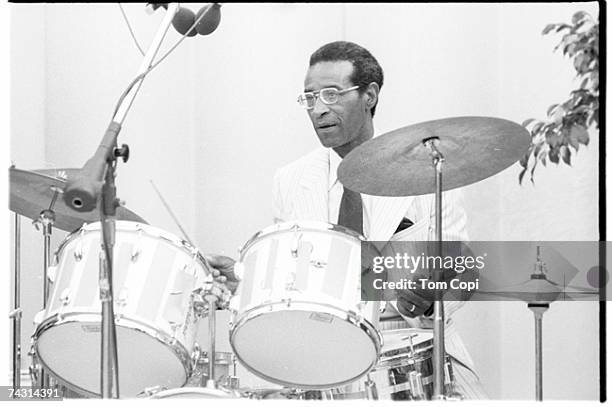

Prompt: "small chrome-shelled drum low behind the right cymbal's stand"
[332,328,453,400]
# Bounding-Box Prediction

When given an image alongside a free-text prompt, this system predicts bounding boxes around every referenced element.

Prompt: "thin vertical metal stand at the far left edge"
[9,213,22,396]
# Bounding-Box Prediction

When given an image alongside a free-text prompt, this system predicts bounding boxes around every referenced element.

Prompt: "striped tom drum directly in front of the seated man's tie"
[230,222,381,389]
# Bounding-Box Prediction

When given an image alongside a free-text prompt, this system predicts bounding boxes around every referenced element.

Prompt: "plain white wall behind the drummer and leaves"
[11,3,599,399]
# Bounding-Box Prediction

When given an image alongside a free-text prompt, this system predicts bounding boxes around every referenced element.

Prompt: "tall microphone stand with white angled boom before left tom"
[94,3,178,398]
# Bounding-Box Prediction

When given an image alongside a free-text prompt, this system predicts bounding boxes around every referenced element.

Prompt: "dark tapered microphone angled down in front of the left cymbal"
[63,122,121,212]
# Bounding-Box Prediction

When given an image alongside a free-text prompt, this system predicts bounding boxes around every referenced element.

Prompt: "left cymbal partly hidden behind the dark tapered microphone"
[9,167,147,232]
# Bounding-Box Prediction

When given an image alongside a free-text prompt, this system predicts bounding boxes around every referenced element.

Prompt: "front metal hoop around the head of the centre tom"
[229,301,383,390]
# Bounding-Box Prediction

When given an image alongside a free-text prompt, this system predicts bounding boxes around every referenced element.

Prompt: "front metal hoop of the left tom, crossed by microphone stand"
[32,312,193,397]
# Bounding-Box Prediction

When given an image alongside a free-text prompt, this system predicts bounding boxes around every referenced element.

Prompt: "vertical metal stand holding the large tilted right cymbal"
[423,137,445,400]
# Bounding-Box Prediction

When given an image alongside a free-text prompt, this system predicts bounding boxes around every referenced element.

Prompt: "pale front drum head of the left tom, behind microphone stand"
[36,321,188,398]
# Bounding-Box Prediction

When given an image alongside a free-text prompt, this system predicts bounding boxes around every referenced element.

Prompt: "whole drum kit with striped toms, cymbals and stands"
[9,113,540,400]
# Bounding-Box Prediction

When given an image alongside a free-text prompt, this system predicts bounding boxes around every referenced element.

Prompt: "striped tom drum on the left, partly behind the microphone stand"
[33,221,210,397]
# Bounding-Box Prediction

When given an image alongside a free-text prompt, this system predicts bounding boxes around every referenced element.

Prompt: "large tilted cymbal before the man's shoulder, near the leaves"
[338,117,531,196]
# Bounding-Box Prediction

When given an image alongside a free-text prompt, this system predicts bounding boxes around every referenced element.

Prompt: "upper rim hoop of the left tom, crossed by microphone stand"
[54,220,210,273]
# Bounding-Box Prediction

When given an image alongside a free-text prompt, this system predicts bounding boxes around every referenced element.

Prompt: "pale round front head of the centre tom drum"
[231,303,378,389]
